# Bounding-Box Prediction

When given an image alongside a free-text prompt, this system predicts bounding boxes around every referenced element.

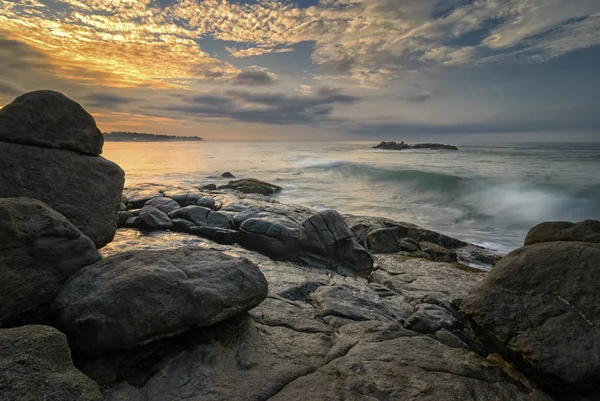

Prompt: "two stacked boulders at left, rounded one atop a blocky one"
[0,91,124,248]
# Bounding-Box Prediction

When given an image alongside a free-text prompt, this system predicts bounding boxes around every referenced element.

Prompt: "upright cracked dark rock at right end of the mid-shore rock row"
[302,210,373,273]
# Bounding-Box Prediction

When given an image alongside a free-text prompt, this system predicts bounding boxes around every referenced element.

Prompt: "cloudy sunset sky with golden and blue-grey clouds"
[0,0,600,142]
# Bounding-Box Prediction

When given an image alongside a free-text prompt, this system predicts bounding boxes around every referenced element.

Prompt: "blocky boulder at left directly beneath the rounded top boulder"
[0,142,125,248]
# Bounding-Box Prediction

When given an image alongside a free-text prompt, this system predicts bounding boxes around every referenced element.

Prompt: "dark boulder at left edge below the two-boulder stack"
[0,198,100,324]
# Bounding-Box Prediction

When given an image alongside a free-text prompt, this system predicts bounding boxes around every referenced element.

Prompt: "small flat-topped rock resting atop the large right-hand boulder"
[525,220,600,245]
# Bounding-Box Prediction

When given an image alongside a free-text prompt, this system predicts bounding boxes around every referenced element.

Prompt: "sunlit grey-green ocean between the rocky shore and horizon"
[103,141,600,252]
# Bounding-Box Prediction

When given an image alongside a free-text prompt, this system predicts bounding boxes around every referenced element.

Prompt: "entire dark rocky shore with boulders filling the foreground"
[0,91,600,401]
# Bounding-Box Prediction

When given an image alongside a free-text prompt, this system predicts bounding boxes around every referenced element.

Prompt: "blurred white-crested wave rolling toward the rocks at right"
[303,159,600,227]
